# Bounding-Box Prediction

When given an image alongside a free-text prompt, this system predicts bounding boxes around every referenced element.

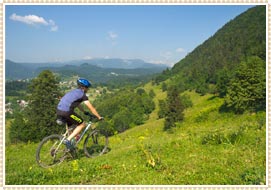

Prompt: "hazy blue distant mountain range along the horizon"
[5,59,168,82]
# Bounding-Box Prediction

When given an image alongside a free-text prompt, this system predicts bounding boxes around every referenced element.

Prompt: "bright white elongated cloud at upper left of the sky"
[9,13,58,32]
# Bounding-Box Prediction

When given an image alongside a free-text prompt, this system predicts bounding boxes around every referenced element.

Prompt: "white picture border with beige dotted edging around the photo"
[0,0,271,190]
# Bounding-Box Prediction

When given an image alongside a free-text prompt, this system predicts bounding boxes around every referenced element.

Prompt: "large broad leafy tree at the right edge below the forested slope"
[225,56,266,113]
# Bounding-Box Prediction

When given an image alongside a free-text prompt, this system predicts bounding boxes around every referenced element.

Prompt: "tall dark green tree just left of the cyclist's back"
[25,70,63,141]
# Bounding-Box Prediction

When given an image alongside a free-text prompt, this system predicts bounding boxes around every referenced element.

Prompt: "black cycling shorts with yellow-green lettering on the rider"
[56,110,84,126]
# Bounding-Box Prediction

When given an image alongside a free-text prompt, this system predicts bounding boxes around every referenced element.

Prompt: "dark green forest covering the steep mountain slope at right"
[155,6,266,95]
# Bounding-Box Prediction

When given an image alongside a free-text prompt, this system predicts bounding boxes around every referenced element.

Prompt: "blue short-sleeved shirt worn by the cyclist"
[57,88,88,112]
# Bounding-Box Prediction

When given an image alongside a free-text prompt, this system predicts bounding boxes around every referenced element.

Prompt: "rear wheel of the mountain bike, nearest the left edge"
[36,134,68,168]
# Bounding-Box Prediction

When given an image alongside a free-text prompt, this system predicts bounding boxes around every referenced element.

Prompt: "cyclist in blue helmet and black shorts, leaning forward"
[57,78,103,150]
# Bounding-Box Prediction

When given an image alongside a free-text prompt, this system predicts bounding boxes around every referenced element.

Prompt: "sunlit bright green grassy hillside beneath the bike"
[5,84,266,185]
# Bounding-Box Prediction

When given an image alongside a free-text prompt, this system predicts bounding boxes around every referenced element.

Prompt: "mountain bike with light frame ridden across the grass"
[36,116,109,168]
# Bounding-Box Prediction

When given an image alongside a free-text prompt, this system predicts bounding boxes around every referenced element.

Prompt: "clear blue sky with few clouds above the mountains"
[5,4,255,65]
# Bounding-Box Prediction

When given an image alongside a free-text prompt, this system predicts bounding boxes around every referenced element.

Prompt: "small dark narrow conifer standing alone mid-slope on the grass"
[164,87,185,130]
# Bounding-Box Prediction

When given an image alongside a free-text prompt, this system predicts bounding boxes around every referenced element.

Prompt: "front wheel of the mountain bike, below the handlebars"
[84,130,109,158]
